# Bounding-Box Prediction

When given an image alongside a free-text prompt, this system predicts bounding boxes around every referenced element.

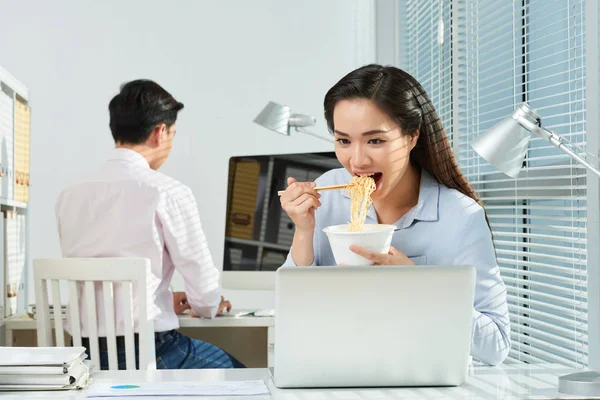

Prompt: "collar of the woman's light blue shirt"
[343,169,440,229]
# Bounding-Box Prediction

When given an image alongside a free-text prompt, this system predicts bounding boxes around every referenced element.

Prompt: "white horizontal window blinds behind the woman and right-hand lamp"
[407,0,587,367]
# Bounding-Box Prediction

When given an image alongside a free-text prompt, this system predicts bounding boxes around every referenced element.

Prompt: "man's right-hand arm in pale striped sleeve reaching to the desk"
[161,188,221,318]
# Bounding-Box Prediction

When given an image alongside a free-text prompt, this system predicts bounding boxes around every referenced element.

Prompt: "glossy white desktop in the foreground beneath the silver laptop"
[0,364,592,400]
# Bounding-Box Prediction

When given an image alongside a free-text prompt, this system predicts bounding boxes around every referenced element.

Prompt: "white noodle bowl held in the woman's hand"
[323,224,396,266]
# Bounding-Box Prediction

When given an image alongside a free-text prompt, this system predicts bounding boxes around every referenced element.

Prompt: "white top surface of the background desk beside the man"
[3,314,275,330]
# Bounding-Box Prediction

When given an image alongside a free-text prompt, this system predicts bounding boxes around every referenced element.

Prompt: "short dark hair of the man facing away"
[108,79,183,144]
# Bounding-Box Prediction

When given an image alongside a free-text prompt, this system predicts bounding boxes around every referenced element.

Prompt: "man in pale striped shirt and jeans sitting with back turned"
[56,80,243,369]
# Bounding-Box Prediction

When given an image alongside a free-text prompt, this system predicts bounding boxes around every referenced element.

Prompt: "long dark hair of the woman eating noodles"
[324,64,487,209]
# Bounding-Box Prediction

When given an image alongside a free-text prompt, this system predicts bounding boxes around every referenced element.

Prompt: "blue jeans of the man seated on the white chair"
[83,330,245,369]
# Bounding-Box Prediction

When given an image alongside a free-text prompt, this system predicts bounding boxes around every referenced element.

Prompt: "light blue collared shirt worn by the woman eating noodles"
[284,168,510,365]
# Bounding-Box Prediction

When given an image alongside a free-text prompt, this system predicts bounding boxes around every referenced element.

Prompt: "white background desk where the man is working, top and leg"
[0,314,275,368]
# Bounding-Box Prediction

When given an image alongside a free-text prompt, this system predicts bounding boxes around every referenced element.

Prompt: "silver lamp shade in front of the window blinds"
[471,103,539,178]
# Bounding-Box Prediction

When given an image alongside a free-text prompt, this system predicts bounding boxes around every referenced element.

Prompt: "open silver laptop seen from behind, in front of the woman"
[270,265,475,388]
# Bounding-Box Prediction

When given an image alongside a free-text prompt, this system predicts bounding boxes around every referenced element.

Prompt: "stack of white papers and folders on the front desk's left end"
[0,347,92,391]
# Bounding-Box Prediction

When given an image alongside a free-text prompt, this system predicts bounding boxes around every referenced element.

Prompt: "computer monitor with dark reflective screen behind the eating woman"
[223,152,341,290]
